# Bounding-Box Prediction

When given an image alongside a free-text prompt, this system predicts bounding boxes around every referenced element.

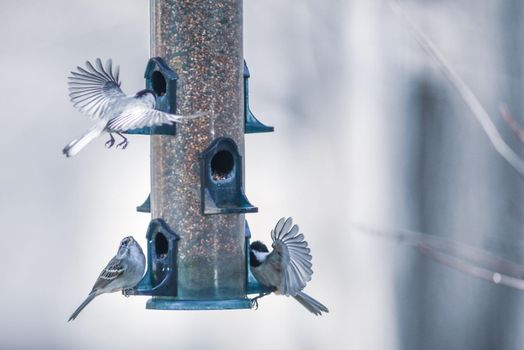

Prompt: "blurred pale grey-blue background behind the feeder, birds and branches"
[0,0,524,349]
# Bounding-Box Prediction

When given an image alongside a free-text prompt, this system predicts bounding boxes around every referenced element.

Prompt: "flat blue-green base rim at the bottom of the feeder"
[146,297,251,310]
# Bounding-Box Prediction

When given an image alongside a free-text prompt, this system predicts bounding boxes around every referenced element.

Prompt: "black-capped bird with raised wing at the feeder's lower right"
[249,218,329,315]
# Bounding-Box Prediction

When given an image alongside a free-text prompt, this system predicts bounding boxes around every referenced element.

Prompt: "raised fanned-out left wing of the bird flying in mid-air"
[69,58,126,119]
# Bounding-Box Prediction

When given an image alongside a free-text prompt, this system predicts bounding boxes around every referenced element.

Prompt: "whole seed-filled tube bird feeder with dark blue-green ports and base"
[129,0,273,310]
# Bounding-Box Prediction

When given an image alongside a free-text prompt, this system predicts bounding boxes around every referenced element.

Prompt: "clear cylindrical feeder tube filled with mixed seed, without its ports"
[147,0,246,300]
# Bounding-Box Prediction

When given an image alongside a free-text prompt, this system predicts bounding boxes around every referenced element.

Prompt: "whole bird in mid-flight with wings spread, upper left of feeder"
[62,58,204,157]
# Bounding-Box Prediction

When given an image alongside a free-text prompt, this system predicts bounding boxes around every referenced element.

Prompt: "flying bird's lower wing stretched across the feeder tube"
[107,103,202,132]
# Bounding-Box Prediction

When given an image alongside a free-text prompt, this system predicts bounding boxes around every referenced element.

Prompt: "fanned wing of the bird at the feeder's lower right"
[268,218,313,295]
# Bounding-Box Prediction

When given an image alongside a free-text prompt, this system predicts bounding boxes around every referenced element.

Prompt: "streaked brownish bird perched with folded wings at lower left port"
[68,236,146,321]
